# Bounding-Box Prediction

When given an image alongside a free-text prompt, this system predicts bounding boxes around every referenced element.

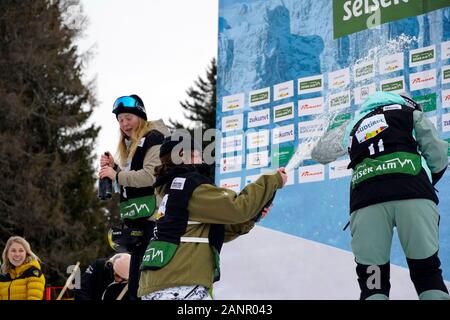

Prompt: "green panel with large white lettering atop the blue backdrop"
[333,0,450,39]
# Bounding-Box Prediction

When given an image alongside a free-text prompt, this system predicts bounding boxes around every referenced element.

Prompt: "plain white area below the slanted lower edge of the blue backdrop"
[214,226,449,300]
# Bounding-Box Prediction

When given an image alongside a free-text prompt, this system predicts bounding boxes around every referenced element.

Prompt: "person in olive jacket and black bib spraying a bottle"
[138,138,287,300]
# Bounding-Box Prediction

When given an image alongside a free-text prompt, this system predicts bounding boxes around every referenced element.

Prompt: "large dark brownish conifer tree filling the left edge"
[0,0,109,284]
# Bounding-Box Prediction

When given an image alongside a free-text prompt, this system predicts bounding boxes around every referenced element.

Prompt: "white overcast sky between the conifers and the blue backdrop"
[80,0,218,162]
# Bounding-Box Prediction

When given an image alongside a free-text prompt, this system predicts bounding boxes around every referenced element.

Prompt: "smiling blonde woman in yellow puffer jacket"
[0,236,45,300]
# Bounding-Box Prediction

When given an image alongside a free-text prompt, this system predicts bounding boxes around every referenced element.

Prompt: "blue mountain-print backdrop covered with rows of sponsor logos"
[216,0,450,279]
